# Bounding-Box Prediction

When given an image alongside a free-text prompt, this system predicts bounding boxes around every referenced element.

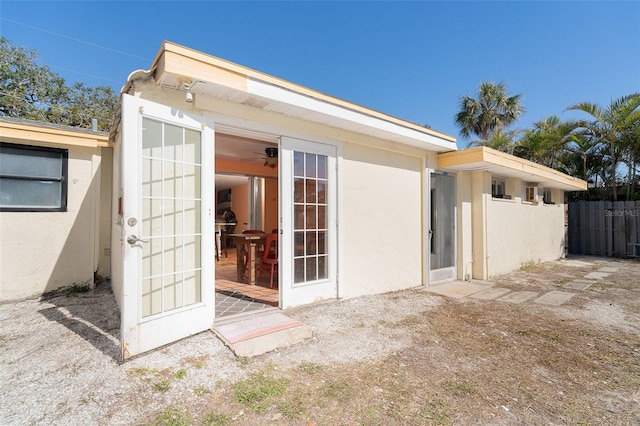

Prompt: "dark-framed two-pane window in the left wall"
[0,143,69,212]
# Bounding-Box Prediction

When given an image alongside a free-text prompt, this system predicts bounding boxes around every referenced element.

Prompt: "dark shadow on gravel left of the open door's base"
[39,282,120,362]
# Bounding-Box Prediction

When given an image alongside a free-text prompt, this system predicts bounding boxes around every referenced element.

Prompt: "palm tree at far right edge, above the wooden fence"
[567,93,640,201]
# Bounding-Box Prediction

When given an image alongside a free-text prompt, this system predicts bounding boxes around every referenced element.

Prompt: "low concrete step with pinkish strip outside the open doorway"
[212,313,312,357]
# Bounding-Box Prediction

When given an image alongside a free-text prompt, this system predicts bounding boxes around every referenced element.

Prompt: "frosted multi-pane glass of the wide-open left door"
[141,118,202,316]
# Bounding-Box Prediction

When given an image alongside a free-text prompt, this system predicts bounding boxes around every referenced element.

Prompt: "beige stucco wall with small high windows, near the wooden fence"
[457,172,565,279]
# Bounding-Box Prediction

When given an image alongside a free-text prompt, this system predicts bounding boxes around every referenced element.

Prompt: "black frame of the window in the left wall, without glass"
[0,141,69,212]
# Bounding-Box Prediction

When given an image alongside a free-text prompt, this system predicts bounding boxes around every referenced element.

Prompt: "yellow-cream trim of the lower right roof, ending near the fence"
[438,146,587,190]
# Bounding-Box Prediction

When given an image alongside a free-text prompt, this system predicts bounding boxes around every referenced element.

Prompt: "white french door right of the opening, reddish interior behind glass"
[278,137,338,309]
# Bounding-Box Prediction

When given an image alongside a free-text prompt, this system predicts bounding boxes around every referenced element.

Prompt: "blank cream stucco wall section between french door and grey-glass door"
[340,143,424,297]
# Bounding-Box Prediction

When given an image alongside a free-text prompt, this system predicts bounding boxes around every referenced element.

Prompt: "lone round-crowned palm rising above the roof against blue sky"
[455,82,525,144]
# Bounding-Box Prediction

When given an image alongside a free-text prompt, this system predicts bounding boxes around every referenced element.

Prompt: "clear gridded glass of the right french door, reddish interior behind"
[293,152,329,283]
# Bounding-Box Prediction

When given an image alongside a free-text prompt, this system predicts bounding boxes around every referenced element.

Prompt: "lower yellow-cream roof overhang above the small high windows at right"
[438,146,587,191]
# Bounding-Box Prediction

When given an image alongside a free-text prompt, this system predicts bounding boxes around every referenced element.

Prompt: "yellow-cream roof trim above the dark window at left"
[0,121,113,148]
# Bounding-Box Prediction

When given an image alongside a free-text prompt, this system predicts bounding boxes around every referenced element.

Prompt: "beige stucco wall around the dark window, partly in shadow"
[0,141,111,301]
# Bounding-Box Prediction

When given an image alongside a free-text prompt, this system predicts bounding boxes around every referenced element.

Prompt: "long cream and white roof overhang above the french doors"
[142,41,457,152]
